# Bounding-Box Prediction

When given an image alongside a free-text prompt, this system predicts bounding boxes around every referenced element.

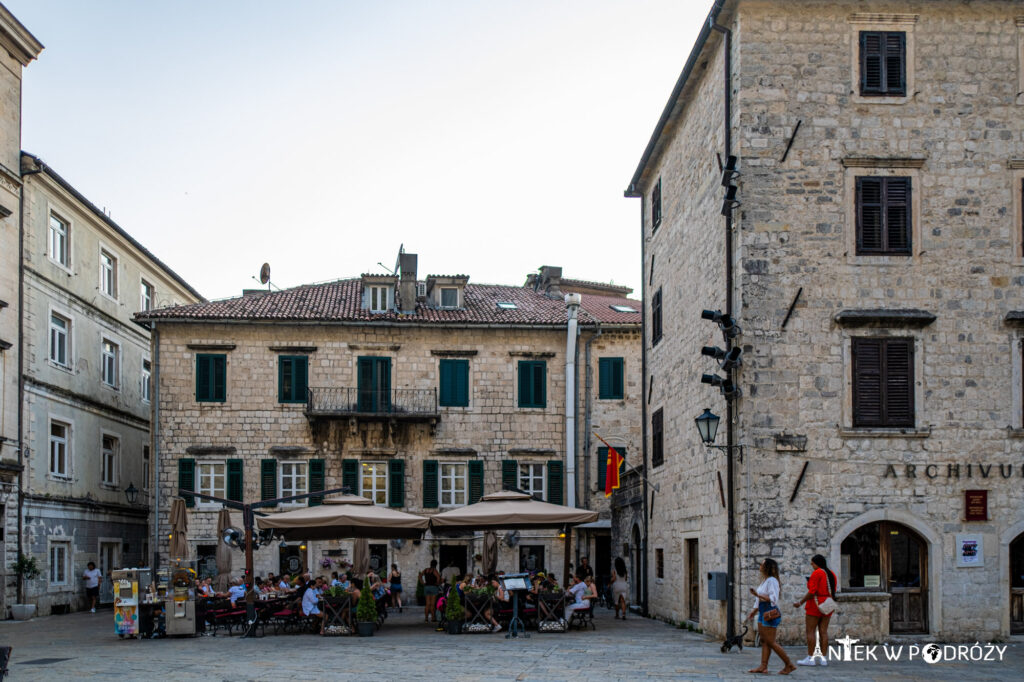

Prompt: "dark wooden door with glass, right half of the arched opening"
[881,523,928,634]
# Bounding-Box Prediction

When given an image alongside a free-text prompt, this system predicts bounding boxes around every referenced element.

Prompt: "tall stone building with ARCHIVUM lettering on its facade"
[623,0,1024,641]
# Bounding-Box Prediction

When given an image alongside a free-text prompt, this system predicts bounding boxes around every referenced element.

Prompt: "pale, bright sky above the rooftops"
[2,0,711,299]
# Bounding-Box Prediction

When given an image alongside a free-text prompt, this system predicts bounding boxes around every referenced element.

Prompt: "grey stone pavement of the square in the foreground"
[0,608,1024,682]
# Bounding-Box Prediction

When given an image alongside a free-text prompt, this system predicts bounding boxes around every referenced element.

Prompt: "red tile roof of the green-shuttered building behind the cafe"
[135,279,641,327]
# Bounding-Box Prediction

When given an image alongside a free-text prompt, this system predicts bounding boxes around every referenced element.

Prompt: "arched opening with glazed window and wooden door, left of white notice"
[840,521,928,634]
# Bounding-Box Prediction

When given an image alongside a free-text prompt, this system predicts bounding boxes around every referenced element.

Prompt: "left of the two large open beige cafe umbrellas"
[256,495,430,540]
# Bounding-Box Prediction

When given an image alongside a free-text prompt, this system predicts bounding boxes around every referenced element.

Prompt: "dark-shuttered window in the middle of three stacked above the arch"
[856,177,911,256]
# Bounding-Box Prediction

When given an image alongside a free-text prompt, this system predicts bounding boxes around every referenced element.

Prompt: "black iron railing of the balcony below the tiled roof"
[306,386,438,418]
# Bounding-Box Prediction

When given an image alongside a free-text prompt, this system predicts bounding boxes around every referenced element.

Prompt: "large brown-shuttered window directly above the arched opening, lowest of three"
[853,338,913,427]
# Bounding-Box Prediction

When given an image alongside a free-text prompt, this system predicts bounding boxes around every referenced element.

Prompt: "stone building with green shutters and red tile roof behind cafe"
[137,254,640,590]
